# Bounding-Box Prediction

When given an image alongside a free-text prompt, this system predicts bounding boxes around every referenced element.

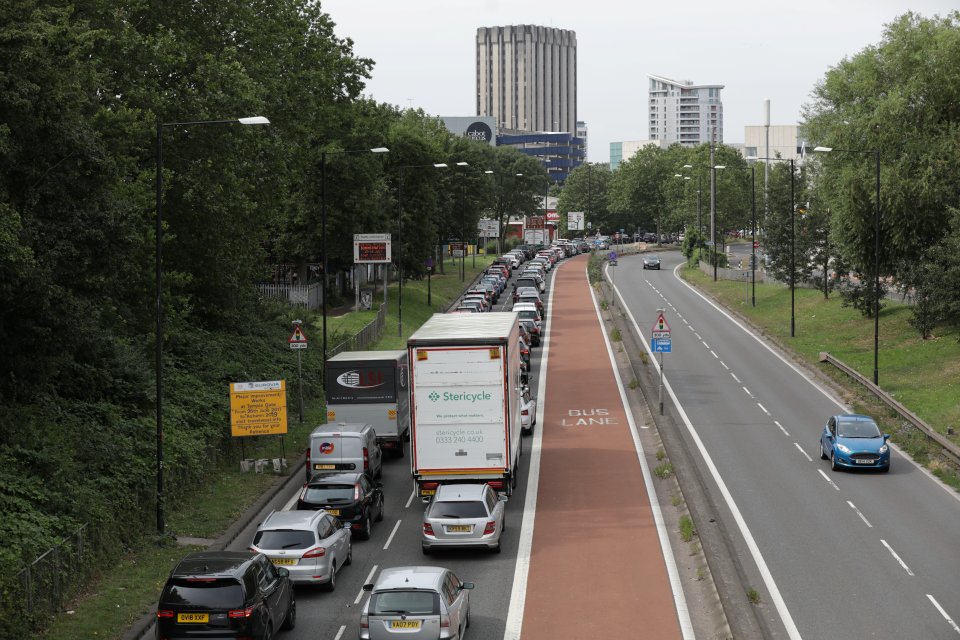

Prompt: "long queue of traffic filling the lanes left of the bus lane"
[156,241,593,640]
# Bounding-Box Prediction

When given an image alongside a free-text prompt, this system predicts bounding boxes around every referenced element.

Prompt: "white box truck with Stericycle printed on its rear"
[407,311,522,499]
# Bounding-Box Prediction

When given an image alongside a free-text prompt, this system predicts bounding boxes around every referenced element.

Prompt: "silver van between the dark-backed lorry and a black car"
[307,422,383,481]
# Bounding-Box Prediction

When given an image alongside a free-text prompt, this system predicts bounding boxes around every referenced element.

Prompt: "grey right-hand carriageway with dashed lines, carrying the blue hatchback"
[616,252,960,639]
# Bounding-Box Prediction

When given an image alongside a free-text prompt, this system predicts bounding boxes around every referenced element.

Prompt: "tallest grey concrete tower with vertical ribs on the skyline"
[477,24,577,134]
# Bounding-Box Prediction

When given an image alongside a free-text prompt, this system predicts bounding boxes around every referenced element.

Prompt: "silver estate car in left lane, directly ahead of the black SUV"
[250,509,353,591]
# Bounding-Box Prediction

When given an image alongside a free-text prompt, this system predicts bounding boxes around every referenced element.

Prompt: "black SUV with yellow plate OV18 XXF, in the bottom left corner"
[157,551,297,640]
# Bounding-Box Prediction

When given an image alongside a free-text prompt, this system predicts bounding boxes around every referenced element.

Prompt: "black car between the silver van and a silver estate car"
[297,472,383,540]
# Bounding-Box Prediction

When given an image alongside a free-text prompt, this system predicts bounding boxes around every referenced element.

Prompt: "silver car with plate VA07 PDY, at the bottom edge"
[360,567,473,640]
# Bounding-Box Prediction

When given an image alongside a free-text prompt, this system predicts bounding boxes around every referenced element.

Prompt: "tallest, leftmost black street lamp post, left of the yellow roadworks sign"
[154,116,270,534]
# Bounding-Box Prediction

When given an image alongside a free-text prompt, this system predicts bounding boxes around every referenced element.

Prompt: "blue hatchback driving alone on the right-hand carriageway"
[820,414,890,471]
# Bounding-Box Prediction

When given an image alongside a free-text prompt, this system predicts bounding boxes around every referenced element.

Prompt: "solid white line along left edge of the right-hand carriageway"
[614,285,801,640]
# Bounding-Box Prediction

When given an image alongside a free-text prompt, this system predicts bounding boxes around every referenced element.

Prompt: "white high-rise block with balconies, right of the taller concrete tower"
[647,74,723,147]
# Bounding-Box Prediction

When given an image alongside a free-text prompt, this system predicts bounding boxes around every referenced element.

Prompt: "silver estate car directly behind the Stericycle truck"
[420,484,507,554]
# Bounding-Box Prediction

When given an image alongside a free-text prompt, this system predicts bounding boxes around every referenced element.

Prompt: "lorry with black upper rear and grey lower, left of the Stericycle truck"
[325,350,410,457]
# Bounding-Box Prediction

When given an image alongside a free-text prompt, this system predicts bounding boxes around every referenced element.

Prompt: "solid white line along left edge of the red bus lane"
[503,268,556,640]
